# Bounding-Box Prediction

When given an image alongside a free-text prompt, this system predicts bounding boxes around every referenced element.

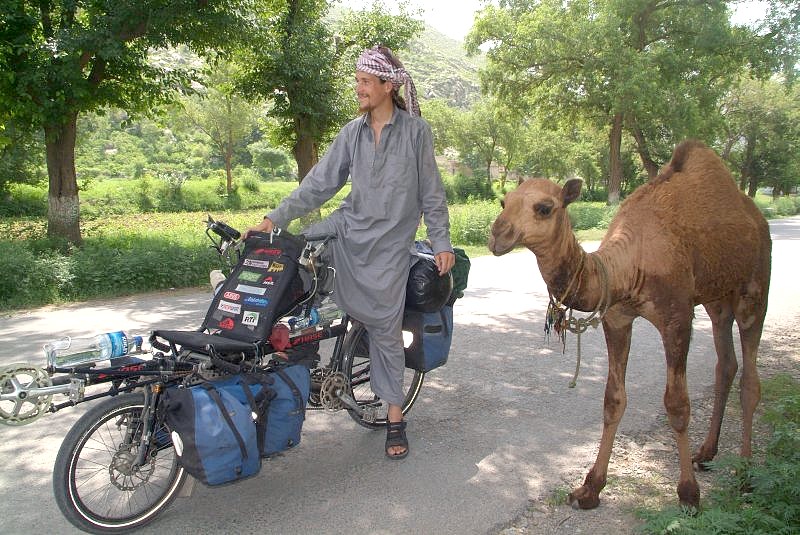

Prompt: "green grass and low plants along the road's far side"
[0,181,796,310]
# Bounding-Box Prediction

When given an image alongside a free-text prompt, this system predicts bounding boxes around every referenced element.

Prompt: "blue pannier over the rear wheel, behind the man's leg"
[403,305,453,372]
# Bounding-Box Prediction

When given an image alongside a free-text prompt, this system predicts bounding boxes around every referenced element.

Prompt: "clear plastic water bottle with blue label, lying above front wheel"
[44,331,143,368]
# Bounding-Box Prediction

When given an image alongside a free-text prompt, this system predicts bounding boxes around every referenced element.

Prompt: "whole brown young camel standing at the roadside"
[489,141,772,509]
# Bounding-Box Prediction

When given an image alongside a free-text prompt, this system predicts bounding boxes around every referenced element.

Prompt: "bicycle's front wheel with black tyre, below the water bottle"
[53,393,186,533]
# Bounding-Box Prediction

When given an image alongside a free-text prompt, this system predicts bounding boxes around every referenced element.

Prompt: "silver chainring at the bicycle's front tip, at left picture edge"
[0,364,53,425]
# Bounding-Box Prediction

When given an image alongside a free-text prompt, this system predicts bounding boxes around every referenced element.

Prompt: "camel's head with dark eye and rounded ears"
[489,178,582,256]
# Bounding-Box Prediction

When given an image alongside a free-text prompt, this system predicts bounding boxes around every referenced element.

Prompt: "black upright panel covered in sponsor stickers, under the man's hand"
[201,232,303,343]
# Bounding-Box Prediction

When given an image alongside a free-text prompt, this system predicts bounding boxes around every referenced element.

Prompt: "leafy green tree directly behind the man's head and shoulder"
[237,0,421,181]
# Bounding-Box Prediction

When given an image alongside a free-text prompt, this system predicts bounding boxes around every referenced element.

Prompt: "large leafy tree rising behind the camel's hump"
[467,0,742,204]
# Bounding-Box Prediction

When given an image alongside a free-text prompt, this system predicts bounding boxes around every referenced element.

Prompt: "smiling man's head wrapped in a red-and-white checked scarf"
[356,46,420,115]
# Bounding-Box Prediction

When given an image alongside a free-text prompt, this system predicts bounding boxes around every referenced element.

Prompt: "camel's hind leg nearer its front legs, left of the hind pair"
[692,301,738,470]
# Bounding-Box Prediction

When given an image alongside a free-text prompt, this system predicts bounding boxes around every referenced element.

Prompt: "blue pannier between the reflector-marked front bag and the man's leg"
[263,364,311,456]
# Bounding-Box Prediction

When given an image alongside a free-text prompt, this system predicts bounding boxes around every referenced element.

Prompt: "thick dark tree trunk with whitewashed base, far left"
[44,113,81,244]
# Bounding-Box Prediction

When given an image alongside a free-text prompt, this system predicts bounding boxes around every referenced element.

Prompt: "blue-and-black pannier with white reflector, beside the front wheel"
[162,375,275,486]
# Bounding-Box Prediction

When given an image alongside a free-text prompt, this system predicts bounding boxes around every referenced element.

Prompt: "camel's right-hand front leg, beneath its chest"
[661,318,700,507]
